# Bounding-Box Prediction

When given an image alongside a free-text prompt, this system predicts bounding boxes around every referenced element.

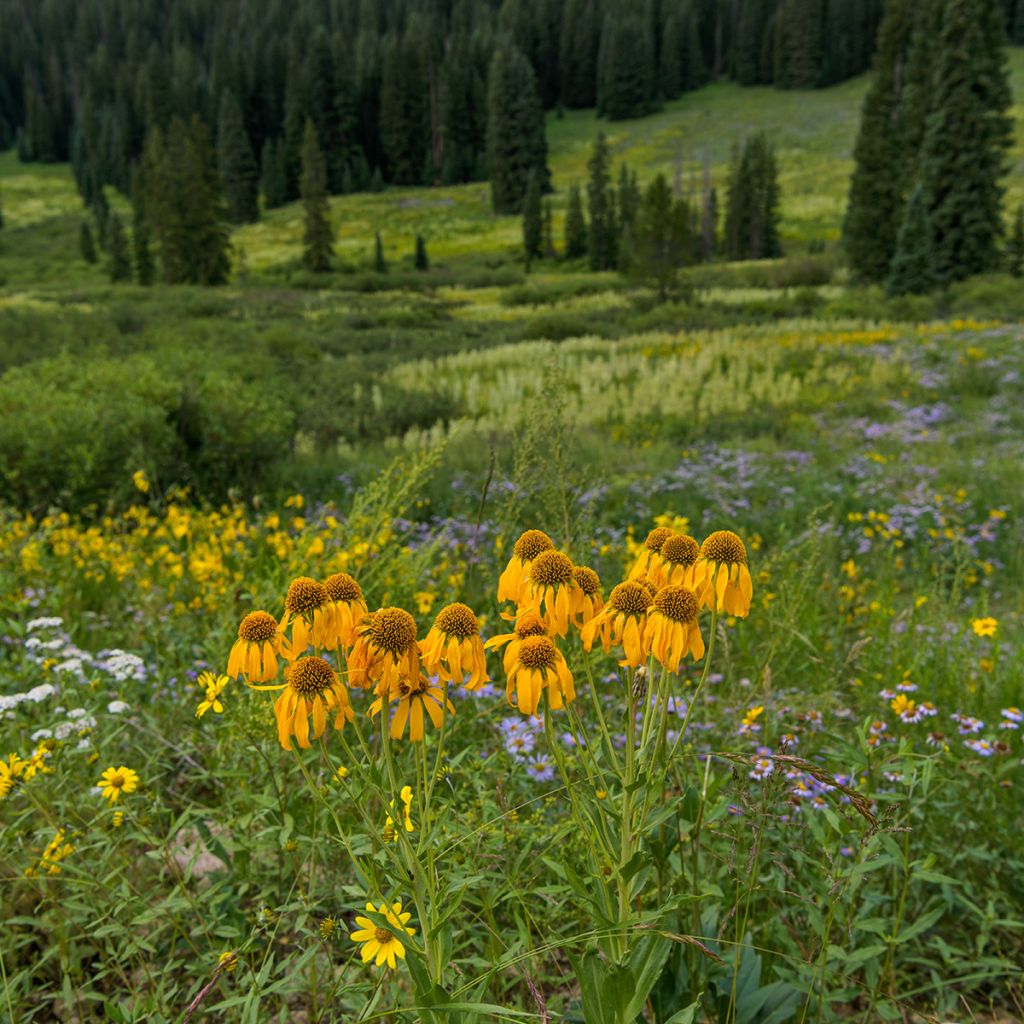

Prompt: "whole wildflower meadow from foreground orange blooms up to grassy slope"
[0,50,1024,1024]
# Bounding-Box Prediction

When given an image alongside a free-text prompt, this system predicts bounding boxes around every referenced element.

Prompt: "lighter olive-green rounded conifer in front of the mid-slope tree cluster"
[625,174,696,302]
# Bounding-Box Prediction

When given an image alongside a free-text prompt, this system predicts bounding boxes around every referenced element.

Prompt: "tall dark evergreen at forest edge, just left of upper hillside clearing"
[487,46,551,213]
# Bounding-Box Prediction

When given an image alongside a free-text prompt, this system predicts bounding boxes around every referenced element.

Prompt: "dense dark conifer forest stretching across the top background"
[0,0,905,206]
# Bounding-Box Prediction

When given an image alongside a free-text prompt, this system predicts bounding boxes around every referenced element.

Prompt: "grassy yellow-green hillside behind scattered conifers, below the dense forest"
[0,48,1024,285]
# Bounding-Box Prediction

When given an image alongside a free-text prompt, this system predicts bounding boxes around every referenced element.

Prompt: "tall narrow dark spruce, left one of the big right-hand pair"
[843,0,914,282]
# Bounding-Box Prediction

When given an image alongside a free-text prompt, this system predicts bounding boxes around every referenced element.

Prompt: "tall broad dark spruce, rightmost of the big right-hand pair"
[917,0,1012,285]
